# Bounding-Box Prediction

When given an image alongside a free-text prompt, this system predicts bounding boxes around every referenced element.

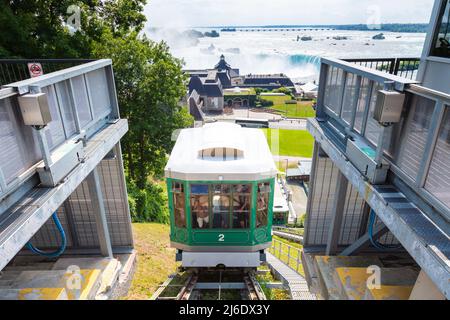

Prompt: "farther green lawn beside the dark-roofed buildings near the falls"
[261,95,316,118]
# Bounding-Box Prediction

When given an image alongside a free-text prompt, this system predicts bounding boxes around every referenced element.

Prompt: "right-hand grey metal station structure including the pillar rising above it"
[304,0,450,299]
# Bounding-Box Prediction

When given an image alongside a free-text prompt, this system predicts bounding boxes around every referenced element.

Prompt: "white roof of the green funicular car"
[165,122,277,181]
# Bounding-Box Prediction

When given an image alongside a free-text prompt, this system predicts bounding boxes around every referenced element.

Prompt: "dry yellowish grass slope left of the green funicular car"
[125,223,177,300]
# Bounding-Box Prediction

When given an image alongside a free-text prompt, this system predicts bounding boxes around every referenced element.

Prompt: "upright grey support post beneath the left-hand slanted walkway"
[87,167,113,258]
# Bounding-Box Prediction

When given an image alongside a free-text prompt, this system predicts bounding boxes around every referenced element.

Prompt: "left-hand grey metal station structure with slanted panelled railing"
[0,59,134,298]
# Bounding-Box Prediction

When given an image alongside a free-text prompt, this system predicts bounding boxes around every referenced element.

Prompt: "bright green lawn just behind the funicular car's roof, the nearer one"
[261,129,314,158]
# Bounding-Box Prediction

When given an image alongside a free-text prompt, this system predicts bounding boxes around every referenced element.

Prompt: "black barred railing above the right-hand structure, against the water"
[343,58,420,79]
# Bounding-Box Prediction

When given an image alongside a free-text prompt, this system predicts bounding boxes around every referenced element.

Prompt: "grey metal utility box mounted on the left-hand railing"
[19,92,52,126]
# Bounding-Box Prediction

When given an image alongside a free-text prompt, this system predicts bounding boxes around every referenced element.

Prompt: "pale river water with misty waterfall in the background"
[149,28,425,81]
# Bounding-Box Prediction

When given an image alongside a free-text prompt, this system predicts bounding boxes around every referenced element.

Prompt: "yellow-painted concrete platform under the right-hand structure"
[336,268,418,300]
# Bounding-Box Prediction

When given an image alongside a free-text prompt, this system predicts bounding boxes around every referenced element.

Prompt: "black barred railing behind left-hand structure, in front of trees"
[0,59,94,86]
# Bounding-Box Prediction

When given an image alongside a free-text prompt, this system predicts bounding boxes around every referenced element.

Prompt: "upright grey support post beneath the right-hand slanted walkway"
[326,170,348,255]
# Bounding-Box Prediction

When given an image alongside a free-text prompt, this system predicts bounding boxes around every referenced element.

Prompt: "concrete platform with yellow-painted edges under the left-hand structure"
[0,251,136,300]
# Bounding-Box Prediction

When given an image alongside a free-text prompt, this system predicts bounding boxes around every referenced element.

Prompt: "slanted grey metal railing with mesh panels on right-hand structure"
[317,58,450,220]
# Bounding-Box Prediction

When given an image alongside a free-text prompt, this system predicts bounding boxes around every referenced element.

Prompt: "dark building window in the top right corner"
[431,0,450,58]
